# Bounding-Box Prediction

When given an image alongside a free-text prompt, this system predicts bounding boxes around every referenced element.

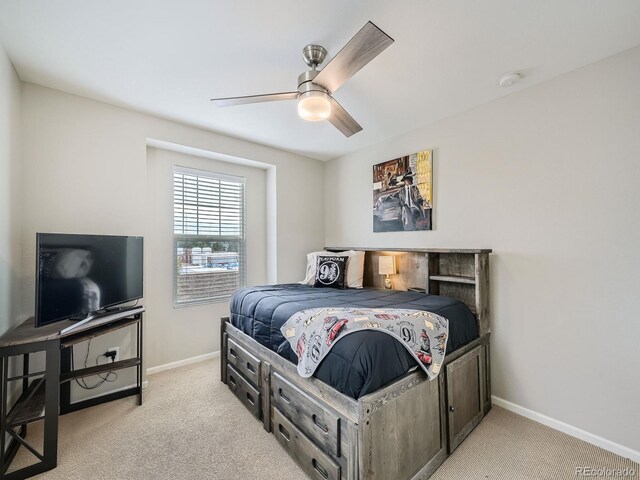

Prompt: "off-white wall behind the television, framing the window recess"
[20,83,324,398]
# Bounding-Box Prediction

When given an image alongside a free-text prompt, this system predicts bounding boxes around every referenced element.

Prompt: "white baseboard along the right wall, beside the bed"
[491,395,640,463]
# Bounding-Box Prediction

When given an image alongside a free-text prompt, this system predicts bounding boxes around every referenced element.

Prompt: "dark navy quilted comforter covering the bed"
[230,283,478,399]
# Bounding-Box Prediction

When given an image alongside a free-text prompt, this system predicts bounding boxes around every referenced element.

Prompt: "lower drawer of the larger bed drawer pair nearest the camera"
[273,408,340,480]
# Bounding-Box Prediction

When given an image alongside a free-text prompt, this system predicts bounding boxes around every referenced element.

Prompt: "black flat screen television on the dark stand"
[35,233,143,327]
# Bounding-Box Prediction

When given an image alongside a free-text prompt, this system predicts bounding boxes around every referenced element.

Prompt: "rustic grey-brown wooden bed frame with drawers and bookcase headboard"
[220,248,491,480]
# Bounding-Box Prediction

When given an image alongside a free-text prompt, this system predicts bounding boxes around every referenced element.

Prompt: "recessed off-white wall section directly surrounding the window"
[145,148,267,365]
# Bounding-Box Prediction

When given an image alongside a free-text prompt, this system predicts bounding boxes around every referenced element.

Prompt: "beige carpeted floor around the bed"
[12,360,640,480]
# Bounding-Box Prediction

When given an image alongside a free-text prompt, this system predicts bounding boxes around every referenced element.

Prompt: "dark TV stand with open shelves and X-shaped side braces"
[0,307,144,480]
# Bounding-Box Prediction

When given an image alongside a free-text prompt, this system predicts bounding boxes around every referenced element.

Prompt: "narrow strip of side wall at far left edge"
[0,46,22,334]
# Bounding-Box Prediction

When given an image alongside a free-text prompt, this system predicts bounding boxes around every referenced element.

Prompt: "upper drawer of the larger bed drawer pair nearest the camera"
[271,372,340,457]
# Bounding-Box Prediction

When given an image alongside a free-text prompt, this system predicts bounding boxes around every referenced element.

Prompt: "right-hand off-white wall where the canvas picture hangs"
[325,48,640,452]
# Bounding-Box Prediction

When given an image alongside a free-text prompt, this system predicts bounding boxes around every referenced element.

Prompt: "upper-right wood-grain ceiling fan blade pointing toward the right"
[313,22,393,93]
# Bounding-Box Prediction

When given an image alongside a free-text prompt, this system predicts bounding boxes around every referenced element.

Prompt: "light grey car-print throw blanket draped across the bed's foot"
[280,308,449,380]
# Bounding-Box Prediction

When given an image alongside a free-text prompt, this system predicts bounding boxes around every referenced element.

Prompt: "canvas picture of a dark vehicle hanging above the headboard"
[373,150,433,232]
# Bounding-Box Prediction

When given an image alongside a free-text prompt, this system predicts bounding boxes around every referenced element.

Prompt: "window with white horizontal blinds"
[173,167,246,306]
